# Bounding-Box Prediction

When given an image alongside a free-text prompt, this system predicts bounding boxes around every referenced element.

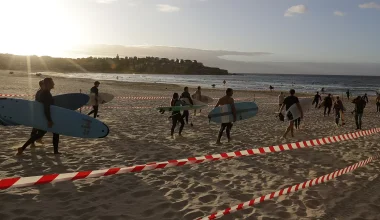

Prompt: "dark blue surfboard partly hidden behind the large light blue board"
[0,93,90,126]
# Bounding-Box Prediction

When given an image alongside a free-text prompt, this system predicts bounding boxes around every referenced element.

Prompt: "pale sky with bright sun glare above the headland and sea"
[0,0,380,63]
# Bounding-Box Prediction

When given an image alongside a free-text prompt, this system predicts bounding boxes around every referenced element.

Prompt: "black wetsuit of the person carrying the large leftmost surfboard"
[21,90,59,153]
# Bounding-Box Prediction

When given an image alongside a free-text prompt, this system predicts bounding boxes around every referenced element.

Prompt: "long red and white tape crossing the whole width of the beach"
[0,128,380,189]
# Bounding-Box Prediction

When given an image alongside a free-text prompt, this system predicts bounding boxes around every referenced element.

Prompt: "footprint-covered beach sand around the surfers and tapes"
[0,71,380,220]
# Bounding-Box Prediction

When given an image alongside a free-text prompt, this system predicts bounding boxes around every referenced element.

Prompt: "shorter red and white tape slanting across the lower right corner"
[198,155,379,220]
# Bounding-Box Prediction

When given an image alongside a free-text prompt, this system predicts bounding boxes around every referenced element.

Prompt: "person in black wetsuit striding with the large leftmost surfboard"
[17,78,60,155]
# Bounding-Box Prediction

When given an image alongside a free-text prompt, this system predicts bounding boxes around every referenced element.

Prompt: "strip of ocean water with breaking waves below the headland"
[43,73,380,95]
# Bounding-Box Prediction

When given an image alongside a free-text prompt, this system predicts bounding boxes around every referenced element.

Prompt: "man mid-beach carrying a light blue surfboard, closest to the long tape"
[215,88,236,144]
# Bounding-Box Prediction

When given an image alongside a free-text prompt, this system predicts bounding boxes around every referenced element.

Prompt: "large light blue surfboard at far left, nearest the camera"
[0,98,109,138]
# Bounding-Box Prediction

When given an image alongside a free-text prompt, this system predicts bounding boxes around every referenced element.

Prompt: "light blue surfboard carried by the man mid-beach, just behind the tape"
[208,102,259,124]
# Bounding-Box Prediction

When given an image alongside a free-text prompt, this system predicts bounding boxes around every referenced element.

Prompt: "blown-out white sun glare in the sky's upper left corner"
[0,0,80,56]
